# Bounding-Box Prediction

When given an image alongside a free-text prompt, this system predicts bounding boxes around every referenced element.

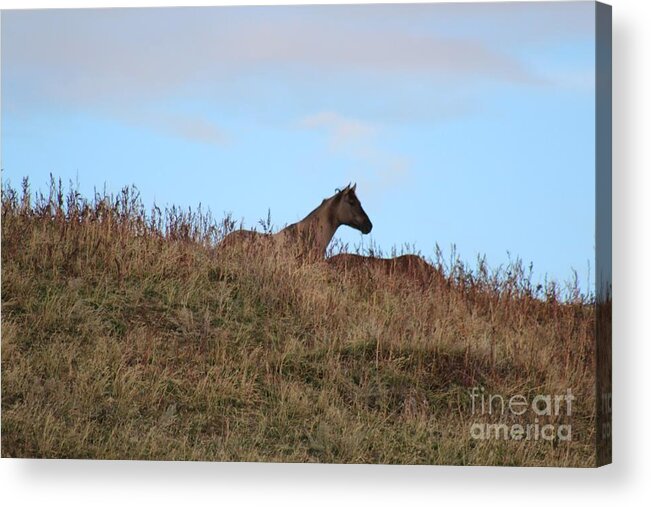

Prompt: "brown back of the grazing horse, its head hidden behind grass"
[326,253,443,287]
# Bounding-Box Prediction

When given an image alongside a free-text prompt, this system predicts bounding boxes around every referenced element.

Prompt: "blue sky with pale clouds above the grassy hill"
[2,2,595,287]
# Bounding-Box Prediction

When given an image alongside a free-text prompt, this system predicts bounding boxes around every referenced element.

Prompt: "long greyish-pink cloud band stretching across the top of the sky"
[2,6,556,112]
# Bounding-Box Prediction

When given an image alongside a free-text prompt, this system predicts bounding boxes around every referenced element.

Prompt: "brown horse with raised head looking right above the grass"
[217,184,373,260]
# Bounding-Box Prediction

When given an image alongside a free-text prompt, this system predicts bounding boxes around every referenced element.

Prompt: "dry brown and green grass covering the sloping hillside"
[2,178,595,466]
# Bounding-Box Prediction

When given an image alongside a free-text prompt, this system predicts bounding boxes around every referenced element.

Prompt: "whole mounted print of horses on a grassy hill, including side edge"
[2,2,611,467]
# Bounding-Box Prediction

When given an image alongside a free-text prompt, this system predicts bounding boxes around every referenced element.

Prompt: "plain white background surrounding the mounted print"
[0,0,651,507]
